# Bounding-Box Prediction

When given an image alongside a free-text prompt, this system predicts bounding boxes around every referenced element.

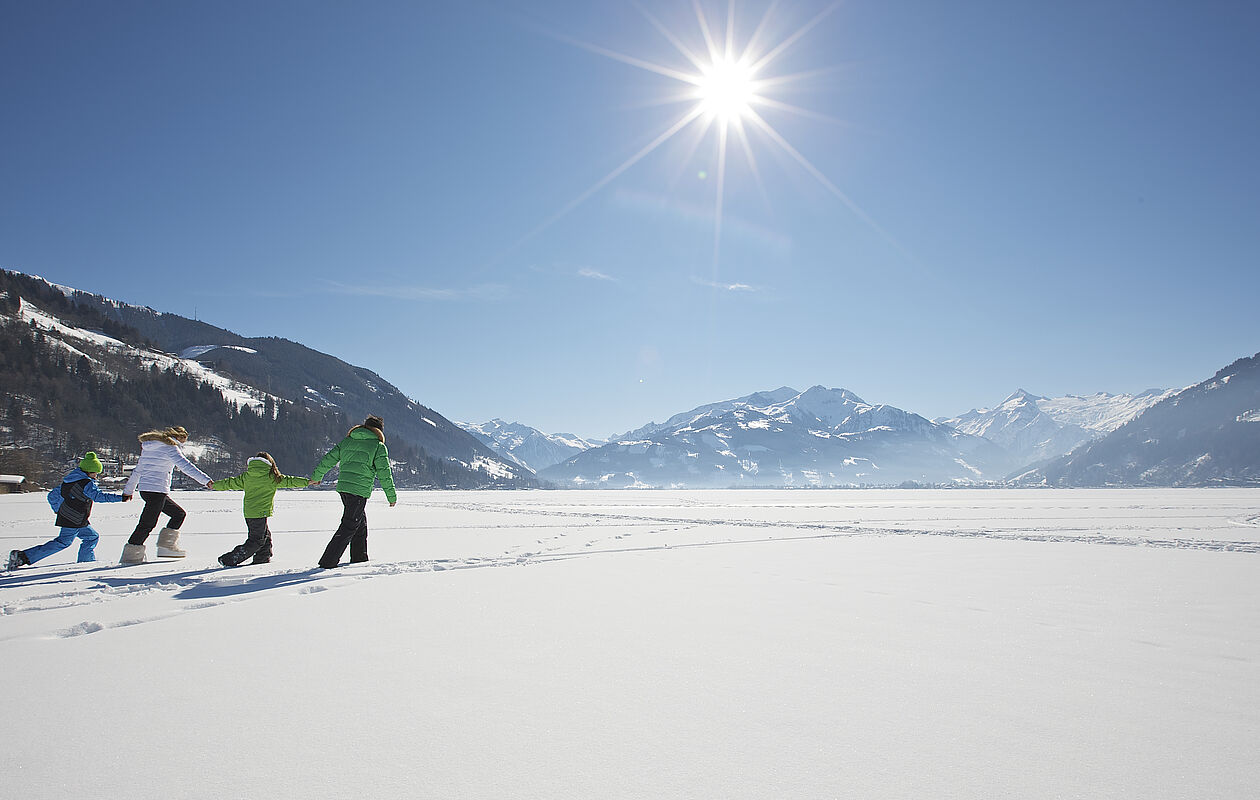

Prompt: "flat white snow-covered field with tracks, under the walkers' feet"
[0,489,1260,800]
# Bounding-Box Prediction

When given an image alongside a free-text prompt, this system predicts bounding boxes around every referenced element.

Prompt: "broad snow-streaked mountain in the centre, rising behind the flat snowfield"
[539,386,1016,488]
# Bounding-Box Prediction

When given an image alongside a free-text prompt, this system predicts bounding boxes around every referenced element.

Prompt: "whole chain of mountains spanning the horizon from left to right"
[9,271,1260,488]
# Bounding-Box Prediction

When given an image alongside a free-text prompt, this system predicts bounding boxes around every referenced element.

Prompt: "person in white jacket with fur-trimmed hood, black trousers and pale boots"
[120,426,214,564]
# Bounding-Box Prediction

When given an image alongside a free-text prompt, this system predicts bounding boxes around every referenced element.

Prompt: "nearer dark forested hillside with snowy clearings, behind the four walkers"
[0,271,526,488]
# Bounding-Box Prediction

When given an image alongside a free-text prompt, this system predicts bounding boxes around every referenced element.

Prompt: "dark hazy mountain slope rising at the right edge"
[1016,354,1260,486]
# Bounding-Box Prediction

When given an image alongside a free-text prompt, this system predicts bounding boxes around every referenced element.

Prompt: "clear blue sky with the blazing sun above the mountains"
[0,0,1260,436]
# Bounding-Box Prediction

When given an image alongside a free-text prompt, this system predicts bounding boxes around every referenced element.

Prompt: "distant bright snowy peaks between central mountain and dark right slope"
[936,389,1176,465]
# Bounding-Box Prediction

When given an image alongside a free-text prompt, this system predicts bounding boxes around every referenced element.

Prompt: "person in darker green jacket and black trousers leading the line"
[311,416,398,569]
